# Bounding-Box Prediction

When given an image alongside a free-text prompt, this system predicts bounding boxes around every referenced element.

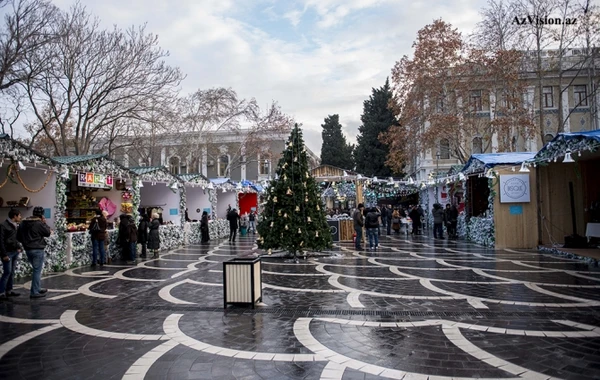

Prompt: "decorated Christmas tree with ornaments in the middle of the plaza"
[257,124,331,260]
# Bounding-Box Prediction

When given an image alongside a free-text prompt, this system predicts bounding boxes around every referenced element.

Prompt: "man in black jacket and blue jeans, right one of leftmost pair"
[17,206,52,298]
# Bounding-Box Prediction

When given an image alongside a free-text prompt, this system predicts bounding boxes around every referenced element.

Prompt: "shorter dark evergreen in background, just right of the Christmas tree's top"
[321,115,354,170]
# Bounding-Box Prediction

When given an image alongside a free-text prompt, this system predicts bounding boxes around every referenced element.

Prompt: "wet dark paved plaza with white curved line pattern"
[0,235,600,380]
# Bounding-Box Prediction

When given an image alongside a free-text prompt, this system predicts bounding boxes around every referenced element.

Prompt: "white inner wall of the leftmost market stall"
[0,166,56,227]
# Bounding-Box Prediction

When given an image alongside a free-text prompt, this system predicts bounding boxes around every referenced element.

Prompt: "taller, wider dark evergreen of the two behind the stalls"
[354,79,398,177]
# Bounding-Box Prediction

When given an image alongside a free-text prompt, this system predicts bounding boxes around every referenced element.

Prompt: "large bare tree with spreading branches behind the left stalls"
[25,5,183,155]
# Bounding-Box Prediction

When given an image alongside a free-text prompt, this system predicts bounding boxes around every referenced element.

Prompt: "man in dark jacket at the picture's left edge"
[0,209,21,299]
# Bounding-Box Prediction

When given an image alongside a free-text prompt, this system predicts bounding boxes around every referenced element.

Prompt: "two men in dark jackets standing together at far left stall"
[0,206,52,300]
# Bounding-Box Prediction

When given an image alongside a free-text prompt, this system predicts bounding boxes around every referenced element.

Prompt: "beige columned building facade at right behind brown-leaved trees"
[406,49,600,181]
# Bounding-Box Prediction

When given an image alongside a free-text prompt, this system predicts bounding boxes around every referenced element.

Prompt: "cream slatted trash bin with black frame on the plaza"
[223,257,262,309]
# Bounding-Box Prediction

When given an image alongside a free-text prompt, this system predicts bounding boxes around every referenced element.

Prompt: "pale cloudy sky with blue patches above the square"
[54,0,485,155]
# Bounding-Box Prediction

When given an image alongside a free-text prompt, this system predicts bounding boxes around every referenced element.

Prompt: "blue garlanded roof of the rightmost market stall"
[535,129,600,161]
